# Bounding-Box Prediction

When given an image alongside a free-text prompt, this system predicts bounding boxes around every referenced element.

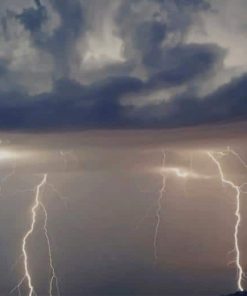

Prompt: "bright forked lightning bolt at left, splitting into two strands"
[10,174,60,296]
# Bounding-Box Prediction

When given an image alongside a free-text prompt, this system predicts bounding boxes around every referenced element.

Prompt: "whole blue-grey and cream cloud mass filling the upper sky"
[0,0,247,130]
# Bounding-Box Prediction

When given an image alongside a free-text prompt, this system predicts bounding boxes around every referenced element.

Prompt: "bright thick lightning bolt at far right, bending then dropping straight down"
[207,152,244,291]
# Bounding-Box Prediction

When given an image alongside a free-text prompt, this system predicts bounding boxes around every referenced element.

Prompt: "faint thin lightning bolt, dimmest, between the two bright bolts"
[153,151,166,264]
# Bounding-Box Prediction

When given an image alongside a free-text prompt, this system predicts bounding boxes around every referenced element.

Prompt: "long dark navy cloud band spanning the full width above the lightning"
[0,69,247,130]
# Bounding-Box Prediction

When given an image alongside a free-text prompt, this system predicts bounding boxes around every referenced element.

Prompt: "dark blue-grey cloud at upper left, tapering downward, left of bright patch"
[16,0,84,78]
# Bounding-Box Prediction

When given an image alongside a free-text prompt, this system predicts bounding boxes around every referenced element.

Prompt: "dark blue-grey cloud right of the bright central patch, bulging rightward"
[116,0,214,79]
